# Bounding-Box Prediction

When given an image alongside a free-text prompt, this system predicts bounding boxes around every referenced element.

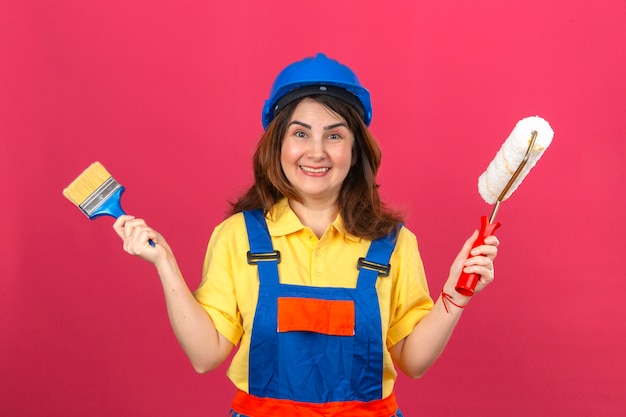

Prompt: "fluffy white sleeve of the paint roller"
[478,116,554,204]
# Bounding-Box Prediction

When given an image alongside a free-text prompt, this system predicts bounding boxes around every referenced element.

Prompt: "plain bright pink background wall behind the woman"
[0,0,626,417]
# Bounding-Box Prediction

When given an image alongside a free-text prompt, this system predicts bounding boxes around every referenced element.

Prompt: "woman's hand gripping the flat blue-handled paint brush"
[113,214,170,264]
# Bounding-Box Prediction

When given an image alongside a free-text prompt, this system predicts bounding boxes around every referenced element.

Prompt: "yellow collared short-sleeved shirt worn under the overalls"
[195,200,433,398]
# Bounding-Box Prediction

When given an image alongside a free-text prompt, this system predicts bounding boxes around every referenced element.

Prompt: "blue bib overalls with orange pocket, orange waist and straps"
[231,211,401,417]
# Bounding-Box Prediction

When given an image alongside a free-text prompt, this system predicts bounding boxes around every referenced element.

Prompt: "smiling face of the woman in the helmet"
[280,98,354,204]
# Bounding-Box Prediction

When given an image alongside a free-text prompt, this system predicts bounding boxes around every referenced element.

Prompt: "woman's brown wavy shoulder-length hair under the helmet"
[231,94,403,240]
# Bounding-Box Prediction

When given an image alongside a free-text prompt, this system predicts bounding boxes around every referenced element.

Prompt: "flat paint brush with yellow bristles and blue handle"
[63,161,155,246]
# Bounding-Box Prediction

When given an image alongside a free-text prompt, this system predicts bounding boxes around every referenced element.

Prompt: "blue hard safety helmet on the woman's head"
[262,53,372,129]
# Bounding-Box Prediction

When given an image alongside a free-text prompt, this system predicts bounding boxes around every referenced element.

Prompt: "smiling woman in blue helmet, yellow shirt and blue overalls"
[114,54,498,417]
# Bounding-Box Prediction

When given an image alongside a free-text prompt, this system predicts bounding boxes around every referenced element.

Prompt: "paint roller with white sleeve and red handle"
[456,116,554,296]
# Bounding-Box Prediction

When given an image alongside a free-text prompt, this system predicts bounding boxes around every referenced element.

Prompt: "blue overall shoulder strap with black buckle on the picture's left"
[243,210,280,284]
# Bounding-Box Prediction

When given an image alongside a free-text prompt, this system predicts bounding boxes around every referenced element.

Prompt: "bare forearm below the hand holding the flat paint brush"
[157,257,233,373]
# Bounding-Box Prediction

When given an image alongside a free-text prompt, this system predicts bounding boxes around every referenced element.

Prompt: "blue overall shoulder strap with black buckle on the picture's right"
[356,226,402,288]
